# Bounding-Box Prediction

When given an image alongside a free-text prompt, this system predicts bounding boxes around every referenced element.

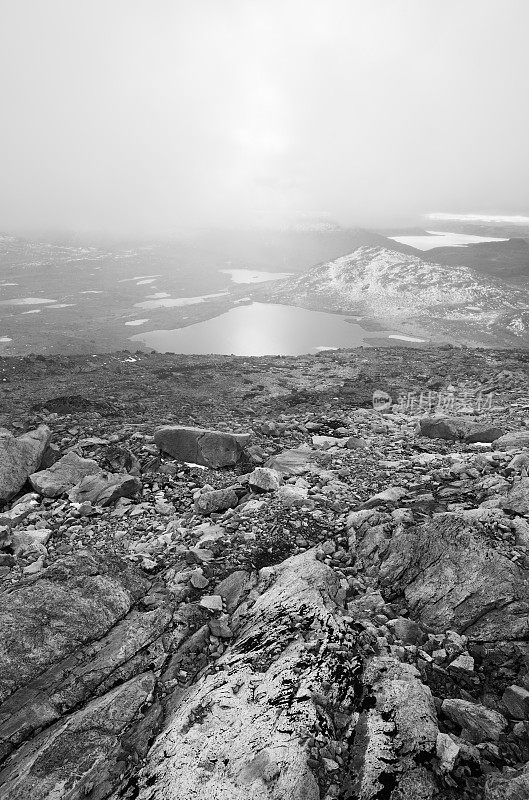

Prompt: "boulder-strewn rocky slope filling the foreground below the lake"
[0,348,529,800]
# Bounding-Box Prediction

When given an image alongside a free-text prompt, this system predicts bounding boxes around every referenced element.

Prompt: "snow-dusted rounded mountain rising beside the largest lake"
[254,242,529,346]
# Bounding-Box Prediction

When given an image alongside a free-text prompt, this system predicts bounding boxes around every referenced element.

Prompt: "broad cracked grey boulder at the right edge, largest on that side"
[357,515,529,642]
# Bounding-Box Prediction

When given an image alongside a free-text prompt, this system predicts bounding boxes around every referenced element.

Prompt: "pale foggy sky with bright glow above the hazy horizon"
[0,0,529,234]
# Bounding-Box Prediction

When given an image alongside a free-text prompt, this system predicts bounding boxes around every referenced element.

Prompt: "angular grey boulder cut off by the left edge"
[0,425,51,501]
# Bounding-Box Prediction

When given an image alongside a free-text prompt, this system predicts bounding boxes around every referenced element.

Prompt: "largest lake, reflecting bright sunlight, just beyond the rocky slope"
[130,303,400,356]
